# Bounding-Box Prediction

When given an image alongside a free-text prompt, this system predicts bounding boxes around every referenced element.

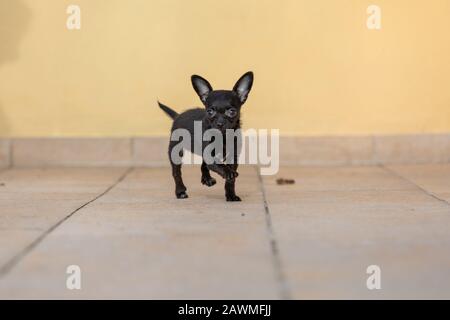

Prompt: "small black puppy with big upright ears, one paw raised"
[158,72,253,201]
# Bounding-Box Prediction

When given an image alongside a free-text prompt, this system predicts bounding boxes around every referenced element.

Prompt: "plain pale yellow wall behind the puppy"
[0,0,450,136]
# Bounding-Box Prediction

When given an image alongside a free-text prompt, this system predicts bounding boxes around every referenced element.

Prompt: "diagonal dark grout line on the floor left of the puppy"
[0,167,134,278]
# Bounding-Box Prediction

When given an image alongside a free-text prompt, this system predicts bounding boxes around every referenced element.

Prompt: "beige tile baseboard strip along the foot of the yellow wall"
[0,134,450,168]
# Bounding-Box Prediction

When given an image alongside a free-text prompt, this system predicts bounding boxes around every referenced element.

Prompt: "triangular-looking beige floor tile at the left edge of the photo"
[0,169,125,268]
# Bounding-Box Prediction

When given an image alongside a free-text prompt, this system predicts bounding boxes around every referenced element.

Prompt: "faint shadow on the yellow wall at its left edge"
[0,0,31,135]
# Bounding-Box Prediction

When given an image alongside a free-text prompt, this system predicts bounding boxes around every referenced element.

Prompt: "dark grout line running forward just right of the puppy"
[255,166,292,300]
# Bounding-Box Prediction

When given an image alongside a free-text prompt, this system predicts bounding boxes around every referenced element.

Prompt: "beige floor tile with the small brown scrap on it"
[264,168,450,299]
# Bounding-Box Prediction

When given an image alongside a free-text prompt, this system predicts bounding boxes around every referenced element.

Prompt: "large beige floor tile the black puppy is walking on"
[0,167,279,299]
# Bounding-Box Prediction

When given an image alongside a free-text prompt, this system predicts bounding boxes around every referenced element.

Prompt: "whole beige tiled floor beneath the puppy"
[0,165,450,299]
